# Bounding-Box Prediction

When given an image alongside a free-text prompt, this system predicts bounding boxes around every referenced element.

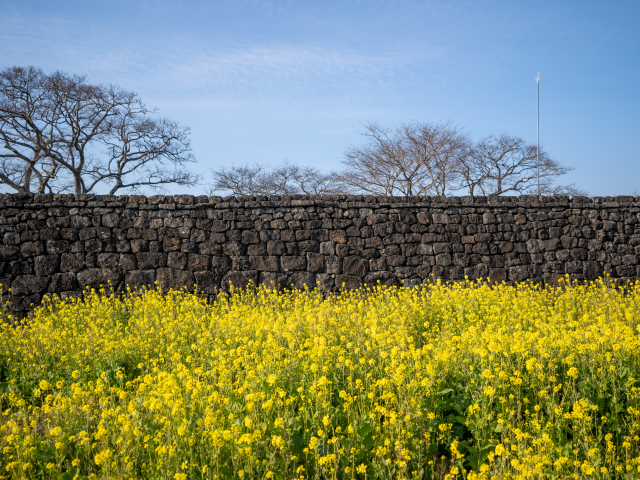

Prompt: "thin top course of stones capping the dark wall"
[0,193,640,208]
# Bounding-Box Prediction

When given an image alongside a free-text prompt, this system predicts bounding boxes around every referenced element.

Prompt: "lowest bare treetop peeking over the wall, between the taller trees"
[208,161,343,195]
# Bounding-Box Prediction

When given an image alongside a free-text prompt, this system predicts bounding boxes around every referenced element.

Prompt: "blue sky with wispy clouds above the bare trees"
[0,0,640,195]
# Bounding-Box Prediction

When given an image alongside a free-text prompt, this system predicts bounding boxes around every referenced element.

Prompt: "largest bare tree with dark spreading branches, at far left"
[0,67,196,194]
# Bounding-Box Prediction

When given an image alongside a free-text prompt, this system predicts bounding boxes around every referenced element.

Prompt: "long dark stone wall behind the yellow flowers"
[0,194,640,316]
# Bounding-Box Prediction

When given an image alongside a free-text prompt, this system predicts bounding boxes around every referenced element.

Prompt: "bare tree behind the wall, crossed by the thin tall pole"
[460,133,584,195]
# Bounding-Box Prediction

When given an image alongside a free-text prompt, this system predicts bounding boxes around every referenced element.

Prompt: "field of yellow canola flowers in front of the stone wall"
[0,281,640,480]
